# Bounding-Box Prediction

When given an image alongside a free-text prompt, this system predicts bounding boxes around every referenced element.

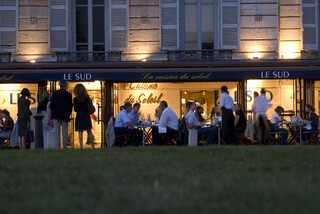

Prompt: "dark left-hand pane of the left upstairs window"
[76,7,88,43]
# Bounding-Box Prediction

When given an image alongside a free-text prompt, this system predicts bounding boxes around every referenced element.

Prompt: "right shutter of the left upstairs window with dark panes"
[109,0,129,51]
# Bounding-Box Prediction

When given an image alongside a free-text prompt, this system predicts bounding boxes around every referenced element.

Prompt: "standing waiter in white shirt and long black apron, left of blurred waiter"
[219,86,234,144]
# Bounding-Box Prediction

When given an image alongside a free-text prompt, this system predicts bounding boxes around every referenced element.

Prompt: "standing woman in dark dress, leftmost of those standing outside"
[18,88,31,150]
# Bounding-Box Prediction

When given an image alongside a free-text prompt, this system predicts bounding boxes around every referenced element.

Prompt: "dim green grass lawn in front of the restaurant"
[0,146,320,214]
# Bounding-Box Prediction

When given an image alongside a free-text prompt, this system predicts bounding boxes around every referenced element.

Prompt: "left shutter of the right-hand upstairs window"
[161,0,179,50]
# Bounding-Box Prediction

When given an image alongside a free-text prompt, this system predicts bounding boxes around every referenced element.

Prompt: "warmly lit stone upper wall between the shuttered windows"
[2,0,320,61]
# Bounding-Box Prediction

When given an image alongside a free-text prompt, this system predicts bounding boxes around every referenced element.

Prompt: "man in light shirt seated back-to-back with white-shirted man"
[186,103,217,145]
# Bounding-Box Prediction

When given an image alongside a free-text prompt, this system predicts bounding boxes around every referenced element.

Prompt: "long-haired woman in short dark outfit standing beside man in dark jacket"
[73,84,94,149]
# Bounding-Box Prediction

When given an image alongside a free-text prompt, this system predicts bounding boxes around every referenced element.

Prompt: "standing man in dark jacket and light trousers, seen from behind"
[50,80,72,149]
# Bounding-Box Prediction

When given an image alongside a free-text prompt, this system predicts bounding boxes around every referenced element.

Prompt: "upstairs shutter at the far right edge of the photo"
[302,0,318,50]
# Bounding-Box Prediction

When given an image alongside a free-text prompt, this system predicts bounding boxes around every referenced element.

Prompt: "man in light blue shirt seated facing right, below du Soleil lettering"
[114,102,140,146]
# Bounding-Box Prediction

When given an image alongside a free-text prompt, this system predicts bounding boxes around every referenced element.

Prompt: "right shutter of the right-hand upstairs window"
[220,0,240,49]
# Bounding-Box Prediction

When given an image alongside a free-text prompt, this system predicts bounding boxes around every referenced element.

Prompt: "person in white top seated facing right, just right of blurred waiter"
[271,106,288,145]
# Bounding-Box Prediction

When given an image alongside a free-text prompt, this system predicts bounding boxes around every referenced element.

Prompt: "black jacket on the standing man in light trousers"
[50,89,72,122]
